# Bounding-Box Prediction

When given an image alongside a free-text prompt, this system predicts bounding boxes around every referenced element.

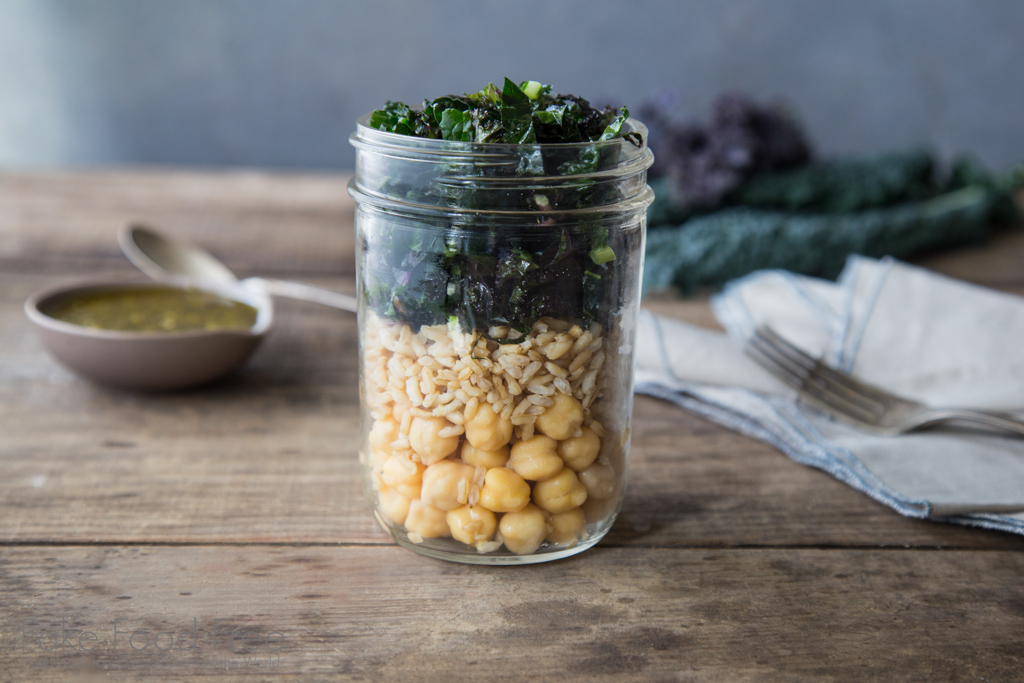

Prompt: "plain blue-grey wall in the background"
[0,0,1024,168]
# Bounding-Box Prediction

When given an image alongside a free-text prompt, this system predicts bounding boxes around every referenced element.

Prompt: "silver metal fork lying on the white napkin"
[744,327,1024,436]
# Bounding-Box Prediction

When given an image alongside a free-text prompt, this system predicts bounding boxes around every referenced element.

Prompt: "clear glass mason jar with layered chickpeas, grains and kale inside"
[349,117,653,564]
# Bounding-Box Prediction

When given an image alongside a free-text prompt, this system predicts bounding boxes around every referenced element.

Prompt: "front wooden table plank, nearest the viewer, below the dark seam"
[0,547,1024,681]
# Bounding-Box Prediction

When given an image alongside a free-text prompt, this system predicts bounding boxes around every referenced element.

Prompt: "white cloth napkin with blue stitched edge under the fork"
[636,257,1024,533]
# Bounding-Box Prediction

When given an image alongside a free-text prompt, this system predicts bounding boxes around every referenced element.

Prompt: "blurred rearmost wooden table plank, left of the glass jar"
[0,168,355,274]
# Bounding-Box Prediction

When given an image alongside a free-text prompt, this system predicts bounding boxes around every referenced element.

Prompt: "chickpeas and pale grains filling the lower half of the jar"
[365,318,617,555]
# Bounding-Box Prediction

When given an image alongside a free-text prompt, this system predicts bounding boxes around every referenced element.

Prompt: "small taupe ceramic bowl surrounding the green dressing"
[25,281,273,391]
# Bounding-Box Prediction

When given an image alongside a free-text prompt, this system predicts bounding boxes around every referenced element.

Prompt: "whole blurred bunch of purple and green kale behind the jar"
[638,93,1024,294]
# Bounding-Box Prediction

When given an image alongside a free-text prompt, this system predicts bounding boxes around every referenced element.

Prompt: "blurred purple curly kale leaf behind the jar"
[639,92,812,207]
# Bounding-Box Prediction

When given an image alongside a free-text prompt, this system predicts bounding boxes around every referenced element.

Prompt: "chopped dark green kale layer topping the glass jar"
[364,79,643,332]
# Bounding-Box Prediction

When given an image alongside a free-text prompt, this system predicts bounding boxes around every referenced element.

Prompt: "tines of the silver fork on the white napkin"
[748,331,883,422]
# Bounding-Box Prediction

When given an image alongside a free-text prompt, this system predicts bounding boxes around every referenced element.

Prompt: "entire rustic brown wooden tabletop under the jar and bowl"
[0,170,1024,681]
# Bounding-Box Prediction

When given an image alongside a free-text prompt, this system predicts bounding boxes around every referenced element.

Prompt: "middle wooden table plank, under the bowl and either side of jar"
[8,274,1024,549]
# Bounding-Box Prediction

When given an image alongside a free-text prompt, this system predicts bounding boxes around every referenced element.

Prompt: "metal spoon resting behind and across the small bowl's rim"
[118,224,358,313]
